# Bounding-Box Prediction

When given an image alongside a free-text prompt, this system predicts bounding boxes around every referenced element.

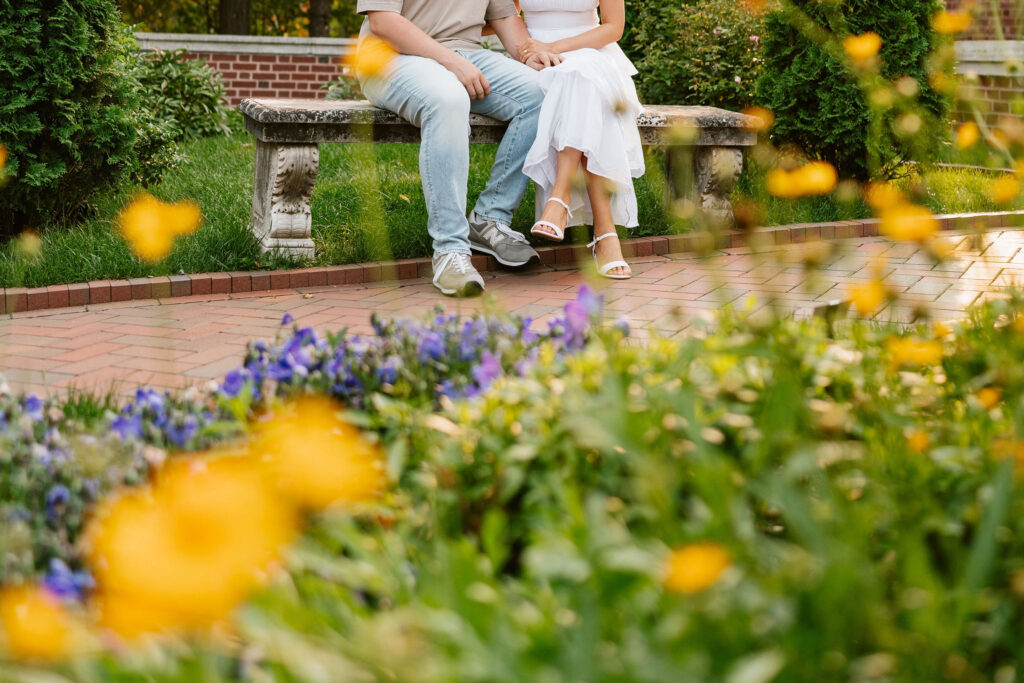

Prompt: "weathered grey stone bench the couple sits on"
[239,99,757,257]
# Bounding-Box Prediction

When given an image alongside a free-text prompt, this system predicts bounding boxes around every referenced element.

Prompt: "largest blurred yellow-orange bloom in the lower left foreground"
[85,455,297,638]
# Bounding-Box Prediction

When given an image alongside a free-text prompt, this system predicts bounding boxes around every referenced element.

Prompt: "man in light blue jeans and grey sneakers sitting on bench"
[356,0,559,296]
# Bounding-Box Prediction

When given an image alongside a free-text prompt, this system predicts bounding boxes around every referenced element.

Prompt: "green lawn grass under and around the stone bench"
[0,134,1024,287]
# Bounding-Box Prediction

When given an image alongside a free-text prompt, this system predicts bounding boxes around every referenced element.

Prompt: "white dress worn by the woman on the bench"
[519,0,644,227]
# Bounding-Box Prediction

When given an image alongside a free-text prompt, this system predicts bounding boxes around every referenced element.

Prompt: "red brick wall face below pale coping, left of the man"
[188,52,341,105]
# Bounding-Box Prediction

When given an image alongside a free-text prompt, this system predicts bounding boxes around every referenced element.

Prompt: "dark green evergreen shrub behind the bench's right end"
[758,0,949,179]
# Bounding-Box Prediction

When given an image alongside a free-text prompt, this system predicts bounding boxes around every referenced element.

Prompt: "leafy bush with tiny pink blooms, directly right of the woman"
[623,0,764,110]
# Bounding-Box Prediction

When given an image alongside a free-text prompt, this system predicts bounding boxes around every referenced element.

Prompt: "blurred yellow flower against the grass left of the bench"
[118,193,203,262]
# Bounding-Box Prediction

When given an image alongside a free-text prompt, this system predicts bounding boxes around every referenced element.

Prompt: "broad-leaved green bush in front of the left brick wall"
[137,50,229,140]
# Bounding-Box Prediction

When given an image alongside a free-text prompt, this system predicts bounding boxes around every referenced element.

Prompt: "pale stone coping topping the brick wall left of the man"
[135,33,356,57]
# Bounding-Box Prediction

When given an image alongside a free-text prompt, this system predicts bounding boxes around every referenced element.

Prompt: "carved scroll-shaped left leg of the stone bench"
[249,140,319,258]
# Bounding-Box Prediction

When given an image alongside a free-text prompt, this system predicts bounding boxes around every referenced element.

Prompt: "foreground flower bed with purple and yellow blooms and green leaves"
[0,286,1024,681]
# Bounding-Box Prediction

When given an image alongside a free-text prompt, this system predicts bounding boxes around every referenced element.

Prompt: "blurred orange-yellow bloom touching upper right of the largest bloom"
[251,397,385,509]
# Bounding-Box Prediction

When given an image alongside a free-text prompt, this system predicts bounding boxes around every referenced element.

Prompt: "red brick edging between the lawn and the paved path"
[0,211,1024,314]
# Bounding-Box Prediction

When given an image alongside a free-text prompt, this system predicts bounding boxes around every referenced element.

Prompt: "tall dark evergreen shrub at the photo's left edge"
[0,0,174,236]
